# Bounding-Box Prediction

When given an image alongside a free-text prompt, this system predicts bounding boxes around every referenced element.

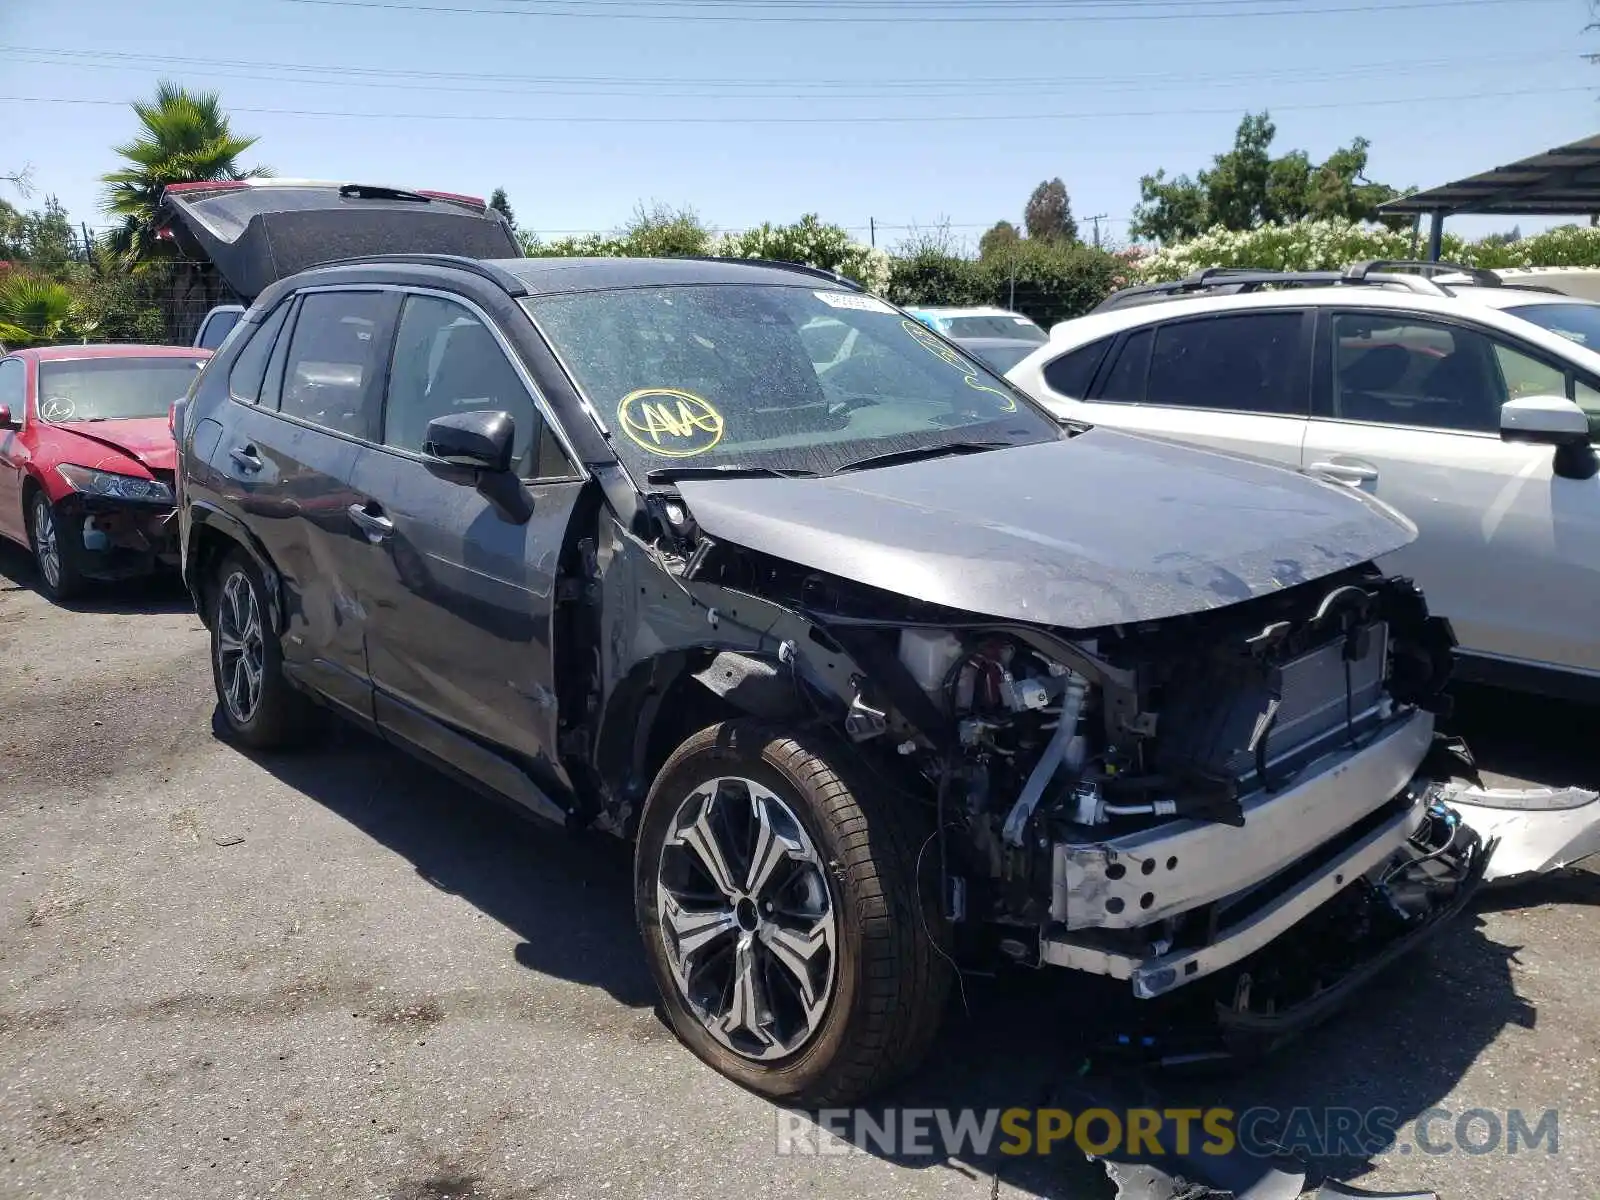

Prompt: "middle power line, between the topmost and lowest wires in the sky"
[0,46,1576,101]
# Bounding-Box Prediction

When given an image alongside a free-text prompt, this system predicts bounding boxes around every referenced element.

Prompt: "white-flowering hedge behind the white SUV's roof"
[1138,221,1600,283]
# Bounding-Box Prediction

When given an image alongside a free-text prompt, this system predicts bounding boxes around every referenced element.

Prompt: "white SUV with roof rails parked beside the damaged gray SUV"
[1006,264,1600,696]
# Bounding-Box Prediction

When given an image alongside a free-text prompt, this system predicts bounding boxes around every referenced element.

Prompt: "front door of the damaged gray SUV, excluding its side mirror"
[350,291,582,814]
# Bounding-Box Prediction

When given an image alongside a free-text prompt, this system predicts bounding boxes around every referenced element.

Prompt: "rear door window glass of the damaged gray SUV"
[280,291,390,437]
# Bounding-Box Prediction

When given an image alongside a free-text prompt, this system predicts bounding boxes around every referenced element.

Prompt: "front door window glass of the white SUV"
[1333,312,1504,434]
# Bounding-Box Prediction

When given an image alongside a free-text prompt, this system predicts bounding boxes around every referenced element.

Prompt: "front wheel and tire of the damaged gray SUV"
[634,722,952,1107]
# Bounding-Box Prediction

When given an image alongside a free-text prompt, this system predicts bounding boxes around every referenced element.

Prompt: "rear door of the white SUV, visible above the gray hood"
[1043,309,1315,467]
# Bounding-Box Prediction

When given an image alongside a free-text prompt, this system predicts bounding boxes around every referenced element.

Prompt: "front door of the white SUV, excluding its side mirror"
[1306,307,1600,681]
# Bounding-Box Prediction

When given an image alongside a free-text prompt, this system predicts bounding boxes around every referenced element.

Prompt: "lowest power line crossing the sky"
[0,85,1590,125]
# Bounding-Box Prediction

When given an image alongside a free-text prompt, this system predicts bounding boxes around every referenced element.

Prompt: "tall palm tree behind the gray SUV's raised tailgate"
[101,80,272,261]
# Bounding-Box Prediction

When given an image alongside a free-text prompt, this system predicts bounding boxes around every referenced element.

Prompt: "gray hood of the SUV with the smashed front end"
[677,429,1416,629]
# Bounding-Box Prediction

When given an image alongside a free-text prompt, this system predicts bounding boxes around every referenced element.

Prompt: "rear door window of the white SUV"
[1144,312,1306,416]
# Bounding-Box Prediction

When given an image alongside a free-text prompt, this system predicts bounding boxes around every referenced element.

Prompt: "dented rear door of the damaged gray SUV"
[211,288,398,720]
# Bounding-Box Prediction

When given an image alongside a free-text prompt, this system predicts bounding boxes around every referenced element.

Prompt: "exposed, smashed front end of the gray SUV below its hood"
[569,501,1493,1046]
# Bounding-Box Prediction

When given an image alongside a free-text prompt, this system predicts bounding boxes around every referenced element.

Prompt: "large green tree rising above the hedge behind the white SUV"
[1131,112,1398,242]
